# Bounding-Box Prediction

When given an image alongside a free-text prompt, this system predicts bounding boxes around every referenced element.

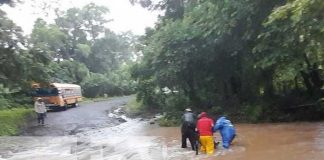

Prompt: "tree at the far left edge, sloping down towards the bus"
[0,11,50,96]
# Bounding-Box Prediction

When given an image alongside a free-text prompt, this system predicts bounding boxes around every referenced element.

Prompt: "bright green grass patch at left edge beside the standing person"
[0,108,34,136]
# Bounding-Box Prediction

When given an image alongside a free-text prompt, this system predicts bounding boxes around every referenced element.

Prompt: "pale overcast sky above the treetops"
[1,0,158,34]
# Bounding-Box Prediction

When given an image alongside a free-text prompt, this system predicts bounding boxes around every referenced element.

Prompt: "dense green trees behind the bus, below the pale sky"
[0,3,136,108]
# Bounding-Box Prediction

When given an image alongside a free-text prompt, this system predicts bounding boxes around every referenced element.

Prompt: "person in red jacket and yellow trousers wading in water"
[197,112,214,154]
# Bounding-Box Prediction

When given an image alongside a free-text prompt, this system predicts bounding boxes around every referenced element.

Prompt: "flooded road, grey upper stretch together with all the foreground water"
[0,97,324,160]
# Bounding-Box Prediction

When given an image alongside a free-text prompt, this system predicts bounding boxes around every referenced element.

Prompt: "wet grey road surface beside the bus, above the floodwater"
[22,96,131,136]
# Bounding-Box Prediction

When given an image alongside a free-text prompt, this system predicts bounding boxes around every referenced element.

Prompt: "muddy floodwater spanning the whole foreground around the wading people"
[0,119,324,160]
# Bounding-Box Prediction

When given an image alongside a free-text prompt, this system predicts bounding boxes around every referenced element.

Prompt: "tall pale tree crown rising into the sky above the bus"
[55,3,109,60]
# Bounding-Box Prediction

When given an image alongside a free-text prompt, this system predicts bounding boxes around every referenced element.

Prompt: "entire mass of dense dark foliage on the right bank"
[132,0,324,120]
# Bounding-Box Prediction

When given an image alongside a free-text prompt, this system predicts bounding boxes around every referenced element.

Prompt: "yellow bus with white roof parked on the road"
[32,83,82,110]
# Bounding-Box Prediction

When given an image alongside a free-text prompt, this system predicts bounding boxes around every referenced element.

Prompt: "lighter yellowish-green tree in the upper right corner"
[254,0,324,97]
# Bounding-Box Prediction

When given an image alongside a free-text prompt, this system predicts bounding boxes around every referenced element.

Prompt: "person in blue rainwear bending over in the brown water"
[213,116,236,149]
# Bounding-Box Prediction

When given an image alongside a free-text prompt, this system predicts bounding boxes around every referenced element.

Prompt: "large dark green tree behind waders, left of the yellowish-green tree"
[132,0,312,119]
